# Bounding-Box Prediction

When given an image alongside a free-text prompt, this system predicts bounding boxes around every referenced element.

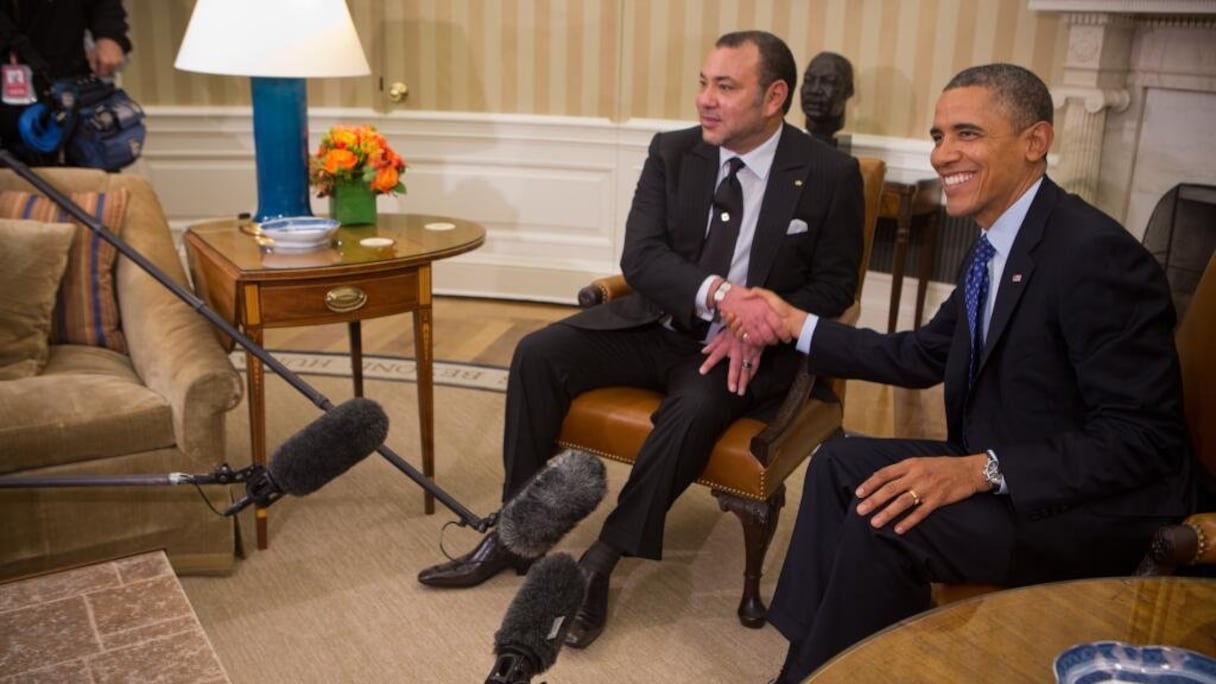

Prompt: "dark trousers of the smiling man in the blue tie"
[767,437,1014,682]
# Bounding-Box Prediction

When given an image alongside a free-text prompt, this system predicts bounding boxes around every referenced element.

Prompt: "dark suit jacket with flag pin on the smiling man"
[810,178,1195,520]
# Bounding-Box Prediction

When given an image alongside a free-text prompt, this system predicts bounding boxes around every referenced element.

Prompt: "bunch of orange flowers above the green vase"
[309,125,406,197]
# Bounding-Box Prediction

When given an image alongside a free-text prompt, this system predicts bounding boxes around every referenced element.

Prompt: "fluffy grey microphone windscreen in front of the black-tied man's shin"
[499,449,608,559]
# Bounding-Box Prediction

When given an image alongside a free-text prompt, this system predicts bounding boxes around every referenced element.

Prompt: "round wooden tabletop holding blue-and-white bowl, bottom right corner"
[806,577,1216,684]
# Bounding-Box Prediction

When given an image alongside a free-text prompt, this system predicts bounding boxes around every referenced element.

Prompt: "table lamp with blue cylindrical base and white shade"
[174,0,371,223]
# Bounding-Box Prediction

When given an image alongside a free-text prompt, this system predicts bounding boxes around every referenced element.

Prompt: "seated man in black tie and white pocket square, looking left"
[418,32,863,647]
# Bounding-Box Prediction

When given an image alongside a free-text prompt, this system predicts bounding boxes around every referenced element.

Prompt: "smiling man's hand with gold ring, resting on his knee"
[856,454,987,534]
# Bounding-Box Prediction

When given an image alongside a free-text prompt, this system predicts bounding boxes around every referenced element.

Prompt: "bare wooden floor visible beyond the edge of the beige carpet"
[265,297,945,439]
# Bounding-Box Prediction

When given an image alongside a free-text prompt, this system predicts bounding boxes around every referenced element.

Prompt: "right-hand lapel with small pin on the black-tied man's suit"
[747,125,815,287]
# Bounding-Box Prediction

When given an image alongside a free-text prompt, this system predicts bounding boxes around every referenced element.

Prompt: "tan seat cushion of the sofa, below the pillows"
[0,344,175,473]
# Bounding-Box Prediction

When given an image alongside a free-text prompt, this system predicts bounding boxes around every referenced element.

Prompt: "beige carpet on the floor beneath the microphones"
[181,352,805,684]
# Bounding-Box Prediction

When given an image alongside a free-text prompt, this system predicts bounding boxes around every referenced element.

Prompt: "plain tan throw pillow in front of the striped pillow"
[0,219,75,377]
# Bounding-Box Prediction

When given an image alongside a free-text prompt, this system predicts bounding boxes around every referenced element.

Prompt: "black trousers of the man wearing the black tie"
[502,323,796,560]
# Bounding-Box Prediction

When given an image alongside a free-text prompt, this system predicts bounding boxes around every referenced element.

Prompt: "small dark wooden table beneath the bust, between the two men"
[878,168,941,332]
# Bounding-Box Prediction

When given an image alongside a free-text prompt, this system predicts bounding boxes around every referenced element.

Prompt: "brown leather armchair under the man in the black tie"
[558,158,886,628]
